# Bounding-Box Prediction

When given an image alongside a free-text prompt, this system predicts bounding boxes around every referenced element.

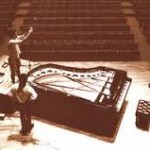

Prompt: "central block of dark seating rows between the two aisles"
[21,0,139,60]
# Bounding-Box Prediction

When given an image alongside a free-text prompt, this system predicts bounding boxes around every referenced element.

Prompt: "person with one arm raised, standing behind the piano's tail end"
[8,27,33,83]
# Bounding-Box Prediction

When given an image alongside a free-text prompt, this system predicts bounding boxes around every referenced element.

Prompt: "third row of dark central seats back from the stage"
[30,31,134,41]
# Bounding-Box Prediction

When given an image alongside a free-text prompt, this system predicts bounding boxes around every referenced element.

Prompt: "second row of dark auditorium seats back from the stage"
[22,40,137,52]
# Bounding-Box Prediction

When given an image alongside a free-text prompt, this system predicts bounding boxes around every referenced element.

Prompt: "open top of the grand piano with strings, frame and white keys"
[29,64,132,112]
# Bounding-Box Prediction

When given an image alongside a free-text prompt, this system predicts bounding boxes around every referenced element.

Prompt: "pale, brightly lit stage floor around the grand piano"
[0,56,150,150]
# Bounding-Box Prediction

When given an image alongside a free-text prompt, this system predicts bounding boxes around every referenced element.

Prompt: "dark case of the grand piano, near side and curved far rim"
[29,64,131,141]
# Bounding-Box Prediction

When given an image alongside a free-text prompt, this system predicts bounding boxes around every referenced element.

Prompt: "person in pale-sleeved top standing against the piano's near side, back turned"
[6,74,37,136]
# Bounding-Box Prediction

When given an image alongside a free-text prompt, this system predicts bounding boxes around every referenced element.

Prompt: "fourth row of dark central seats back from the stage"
[23,24,130,32]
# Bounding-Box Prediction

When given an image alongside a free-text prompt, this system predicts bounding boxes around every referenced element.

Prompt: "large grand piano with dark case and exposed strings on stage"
[29,64,132,141]
